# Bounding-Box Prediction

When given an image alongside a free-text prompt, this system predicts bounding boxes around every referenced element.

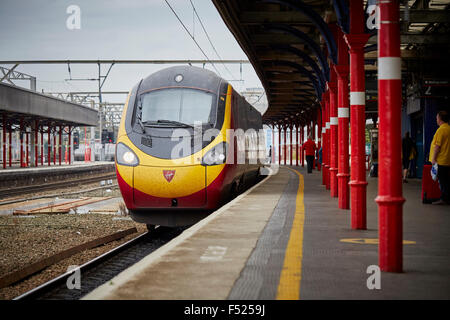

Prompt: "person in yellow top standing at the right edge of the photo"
[429,111,450,204]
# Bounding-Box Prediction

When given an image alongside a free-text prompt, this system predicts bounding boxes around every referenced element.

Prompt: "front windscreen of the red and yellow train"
[141,88,216,125]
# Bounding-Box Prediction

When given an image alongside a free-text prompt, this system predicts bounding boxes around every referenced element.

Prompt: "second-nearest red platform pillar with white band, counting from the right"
[345,0,369,230]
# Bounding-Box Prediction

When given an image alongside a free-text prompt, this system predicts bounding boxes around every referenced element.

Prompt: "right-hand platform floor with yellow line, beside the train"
[84,167,450,300]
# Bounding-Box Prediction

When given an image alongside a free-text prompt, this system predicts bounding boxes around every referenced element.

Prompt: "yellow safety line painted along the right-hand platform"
[277,168,305,300]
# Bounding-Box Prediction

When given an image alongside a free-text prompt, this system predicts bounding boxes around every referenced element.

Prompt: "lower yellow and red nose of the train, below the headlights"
[116,142,226,209]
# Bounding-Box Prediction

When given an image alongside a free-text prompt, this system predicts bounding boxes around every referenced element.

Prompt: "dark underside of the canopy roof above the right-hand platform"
[213,0,450,124]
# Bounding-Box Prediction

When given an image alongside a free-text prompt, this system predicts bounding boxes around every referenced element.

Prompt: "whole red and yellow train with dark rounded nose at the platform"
[115,66,266,229]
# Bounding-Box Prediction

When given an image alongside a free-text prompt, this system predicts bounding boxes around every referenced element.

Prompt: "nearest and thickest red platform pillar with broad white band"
[375,0,405,272]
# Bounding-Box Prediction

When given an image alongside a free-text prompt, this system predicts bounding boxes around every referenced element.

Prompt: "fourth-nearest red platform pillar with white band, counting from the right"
[328,65,338,197]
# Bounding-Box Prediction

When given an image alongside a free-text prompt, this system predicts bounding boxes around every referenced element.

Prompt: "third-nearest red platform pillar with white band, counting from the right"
[334,29,350,209]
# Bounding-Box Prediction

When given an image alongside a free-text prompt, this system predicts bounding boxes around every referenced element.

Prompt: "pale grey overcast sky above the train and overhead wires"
[0,0,261,110]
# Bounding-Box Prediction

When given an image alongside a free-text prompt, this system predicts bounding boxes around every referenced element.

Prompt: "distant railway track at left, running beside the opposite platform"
[0,173,116,199]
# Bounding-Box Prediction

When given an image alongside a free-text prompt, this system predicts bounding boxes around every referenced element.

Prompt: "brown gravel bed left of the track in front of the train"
[0,214,146,299]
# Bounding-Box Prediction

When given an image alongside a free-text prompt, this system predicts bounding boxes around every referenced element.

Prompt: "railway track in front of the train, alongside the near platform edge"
[14,227,186,300]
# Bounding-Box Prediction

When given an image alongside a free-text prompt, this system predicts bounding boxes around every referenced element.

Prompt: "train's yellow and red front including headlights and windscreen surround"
[116,86,233,211]
